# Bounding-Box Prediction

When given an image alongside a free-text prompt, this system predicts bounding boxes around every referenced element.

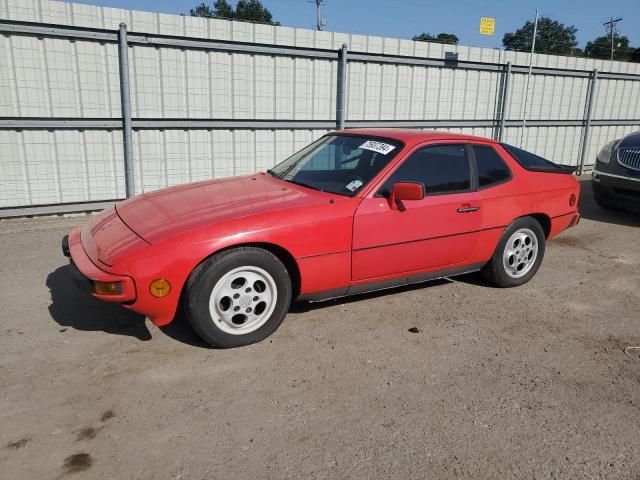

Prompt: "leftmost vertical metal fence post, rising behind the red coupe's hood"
[118,23,135,198]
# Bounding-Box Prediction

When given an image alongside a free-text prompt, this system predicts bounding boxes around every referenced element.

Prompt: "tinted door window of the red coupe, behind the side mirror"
[380,145,471,195]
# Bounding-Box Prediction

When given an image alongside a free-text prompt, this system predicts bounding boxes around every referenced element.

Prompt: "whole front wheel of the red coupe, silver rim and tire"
[184,247,291,348]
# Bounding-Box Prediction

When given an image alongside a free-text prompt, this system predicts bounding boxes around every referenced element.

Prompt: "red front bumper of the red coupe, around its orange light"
[62,229,136,303]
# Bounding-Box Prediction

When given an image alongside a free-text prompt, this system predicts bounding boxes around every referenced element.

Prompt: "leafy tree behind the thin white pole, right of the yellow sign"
[502,17,578,55]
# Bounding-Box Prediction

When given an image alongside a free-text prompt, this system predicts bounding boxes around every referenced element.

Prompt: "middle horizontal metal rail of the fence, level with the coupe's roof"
[0,117,640,130]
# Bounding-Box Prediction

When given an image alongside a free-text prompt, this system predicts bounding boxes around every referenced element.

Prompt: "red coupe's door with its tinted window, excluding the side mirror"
[352,143,482,282]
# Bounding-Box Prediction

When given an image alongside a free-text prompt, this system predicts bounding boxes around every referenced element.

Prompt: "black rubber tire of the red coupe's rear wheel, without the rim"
[482,217,545,288]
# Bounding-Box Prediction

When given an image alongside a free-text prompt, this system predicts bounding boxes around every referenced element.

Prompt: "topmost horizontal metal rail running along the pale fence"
[0,20,640,81]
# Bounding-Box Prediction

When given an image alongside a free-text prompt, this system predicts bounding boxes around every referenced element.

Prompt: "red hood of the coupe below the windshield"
[116,174,326,244]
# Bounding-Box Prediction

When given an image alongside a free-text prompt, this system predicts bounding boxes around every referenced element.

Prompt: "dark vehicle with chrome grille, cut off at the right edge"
[591,132,640,212]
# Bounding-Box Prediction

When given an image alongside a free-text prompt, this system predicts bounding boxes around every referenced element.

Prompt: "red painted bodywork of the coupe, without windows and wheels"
[69,129,579,325]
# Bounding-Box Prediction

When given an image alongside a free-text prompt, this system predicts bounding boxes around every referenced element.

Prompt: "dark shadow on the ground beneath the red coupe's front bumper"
[46,265,151,341]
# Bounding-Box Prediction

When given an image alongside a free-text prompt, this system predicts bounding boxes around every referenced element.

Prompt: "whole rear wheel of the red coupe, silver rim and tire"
[482,217,545,288]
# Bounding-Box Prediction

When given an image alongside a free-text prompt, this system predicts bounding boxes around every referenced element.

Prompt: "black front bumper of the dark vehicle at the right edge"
[591,170,640,212]
